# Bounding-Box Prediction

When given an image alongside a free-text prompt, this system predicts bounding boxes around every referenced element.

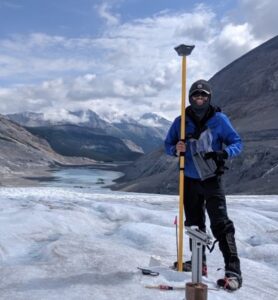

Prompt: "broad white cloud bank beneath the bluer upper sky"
[0,0,274,119]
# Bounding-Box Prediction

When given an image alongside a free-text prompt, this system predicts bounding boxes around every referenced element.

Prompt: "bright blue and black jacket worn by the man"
[165,105,242,179]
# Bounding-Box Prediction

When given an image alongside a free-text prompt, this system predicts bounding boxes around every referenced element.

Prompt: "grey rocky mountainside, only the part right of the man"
[210,36,278,194]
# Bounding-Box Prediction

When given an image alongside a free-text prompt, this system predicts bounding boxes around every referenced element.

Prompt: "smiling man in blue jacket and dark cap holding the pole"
[165,80,242,290]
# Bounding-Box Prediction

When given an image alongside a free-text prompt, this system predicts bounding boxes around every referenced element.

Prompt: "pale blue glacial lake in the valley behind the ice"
[40,167,123,190]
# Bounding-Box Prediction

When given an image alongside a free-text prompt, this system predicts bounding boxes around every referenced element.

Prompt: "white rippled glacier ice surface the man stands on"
[0,187,278,300]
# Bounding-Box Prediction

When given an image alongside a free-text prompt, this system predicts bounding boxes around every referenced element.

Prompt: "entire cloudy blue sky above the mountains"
[0,0,278,119]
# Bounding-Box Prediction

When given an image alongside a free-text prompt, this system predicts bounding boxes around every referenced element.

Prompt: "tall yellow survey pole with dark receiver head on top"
[175,45,194,272]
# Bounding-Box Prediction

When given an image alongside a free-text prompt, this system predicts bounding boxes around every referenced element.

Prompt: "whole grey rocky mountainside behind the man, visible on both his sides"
[112,36,278,194]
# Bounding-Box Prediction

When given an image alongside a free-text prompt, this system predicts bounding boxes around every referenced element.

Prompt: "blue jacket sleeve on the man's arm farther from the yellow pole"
[221,114,242,157]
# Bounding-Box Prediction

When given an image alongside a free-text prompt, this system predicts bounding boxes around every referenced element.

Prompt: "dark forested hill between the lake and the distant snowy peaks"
[27,124,141,162]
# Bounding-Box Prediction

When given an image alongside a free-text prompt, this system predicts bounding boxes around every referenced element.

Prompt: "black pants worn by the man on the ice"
[184,176,241,275]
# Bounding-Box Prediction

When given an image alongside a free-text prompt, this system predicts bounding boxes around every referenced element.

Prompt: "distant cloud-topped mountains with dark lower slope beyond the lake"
[7,110,170,161]
